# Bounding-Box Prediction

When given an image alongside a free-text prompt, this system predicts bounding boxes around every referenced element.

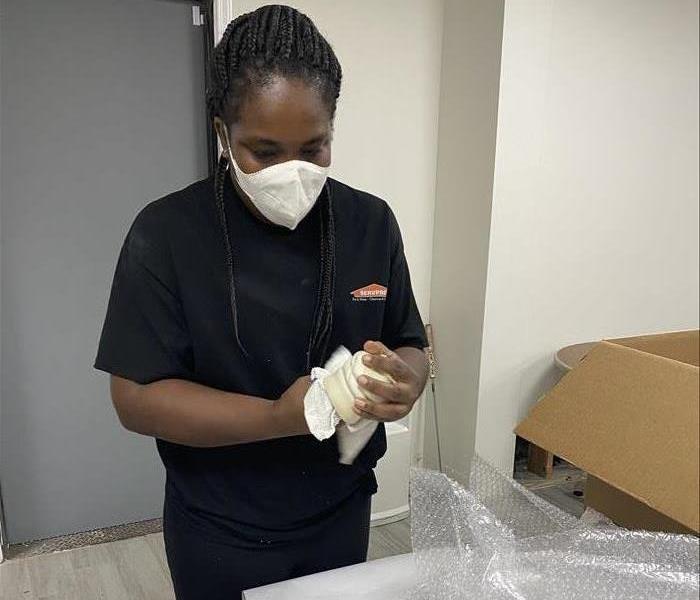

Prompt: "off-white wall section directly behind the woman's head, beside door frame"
[222,0,443,319]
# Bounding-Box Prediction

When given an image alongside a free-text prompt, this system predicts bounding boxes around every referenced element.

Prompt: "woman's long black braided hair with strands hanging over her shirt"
[207,4,342,371]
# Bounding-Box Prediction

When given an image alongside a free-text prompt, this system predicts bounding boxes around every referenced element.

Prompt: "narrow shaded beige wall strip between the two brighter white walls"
[425,0,503,477]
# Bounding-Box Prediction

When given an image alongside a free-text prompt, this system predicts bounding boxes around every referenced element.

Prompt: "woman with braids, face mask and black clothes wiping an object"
[94,5,427,600]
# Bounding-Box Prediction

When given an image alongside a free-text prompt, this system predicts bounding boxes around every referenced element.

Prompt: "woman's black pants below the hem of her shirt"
[163,490,372,600]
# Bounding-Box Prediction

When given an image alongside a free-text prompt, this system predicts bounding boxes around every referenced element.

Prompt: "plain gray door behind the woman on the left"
[0,0,206,542]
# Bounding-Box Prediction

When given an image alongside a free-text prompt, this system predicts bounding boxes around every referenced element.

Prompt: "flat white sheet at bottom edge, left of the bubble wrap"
[243,554,416,600]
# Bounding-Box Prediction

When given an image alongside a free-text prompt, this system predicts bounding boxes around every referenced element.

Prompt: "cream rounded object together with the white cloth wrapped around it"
[304,346,393,465]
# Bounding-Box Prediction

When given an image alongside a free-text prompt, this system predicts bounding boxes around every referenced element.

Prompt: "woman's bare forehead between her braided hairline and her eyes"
[233,77,330,143]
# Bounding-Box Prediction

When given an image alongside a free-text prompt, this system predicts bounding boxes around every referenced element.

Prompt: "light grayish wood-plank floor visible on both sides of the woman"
[0,519,411,600]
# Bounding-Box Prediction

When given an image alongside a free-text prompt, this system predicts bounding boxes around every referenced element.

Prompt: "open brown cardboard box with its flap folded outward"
[515,331,700,534]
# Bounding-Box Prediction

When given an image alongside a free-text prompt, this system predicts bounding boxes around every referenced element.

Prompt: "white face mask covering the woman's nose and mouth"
[228,146,329,229]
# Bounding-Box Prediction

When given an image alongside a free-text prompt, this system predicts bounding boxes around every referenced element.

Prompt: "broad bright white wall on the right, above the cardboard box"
[476,0,698,470]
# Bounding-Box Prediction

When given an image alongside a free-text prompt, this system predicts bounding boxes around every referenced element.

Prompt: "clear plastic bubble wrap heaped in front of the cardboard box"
[410,457,700,600]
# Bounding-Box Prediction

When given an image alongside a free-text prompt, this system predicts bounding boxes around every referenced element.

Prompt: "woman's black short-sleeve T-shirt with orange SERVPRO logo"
[94,177,426,542]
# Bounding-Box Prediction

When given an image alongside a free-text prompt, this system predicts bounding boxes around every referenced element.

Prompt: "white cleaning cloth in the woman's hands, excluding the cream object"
[304,346,390,465]
